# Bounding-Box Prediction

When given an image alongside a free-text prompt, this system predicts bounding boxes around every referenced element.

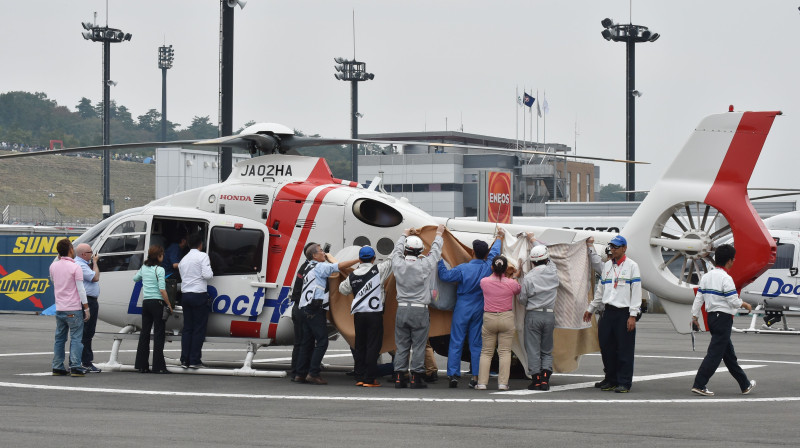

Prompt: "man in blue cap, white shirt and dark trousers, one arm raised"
[583,235,642,393]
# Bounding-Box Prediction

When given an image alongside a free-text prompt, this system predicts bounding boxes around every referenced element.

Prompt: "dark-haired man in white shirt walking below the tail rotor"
[692,244,756,397]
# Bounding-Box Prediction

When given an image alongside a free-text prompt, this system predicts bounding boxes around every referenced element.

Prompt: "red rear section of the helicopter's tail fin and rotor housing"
[705,112,779,289]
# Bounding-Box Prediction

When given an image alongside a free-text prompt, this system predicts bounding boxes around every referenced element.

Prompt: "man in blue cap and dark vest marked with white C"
[339,246,392,387]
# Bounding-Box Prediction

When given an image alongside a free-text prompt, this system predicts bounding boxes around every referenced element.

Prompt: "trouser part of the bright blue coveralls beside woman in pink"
[447,303,483,377]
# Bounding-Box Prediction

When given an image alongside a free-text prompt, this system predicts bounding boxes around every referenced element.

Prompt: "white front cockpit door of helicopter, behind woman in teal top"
[94,216,152,325]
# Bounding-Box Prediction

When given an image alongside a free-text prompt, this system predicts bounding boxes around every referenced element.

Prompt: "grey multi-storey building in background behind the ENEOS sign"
[358,131,599,217]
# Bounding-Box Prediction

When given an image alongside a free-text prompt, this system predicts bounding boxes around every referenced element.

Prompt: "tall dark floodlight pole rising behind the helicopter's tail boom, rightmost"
[600,18,661,202]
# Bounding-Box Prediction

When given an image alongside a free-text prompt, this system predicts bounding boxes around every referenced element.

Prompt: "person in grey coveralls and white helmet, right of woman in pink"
[519,233,559,390]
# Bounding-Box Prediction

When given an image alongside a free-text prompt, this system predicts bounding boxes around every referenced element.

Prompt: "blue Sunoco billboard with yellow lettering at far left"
[0,231,80,312]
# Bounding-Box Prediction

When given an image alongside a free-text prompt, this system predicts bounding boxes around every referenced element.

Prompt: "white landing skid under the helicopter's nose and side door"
[96,325,286,378]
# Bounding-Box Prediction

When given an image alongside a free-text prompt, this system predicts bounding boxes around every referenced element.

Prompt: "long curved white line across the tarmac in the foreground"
[0,382,800,404]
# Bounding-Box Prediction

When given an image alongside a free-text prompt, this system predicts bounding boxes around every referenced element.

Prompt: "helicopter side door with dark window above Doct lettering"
[208,220,266,320]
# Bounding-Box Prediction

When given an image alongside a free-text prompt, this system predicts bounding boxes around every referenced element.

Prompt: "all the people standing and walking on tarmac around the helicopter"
[50,225,756,396]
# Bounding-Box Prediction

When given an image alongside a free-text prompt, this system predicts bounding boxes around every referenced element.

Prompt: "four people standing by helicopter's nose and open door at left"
[50,234,213,376]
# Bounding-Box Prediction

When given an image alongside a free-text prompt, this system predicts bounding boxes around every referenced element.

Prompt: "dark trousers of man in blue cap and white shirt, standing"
[597,305,636,389]
